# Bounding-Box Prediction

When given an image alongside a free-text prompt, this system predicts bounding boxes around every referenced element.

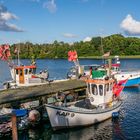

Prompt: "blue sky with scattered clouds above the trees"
[0,0,140,44]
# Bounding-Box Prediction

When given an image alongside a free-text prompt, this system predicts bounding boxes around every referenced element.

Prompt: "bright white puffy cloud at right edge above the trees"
[120,15,140,35]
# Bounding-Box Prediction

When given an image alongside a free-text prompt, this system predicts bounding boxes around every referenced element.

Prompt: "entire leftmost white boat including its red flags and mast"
[0,44,49,89]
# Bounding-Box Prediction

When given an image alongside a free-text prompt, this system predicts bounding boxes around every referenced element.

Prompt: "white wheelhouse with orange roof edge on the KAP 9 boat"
[86,79,114,106]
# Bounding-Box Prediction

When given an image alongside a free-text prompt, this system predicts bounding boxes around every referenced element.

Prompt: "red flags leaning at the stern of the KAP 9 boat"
[113,79,128,97]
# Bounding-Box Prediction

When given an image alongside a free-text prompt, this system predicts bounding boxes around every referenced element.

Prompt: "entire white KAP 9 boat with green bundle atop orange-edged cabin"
[45,62,127,130]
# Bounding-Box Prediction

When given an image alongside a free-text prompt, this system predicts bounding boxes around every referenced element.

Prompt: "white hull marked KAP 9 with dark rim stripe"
[46,101,122,130]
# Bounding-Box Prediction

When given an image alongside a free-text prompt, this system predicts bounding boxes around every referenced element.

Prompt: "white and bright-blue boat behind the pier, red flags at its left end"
[67,50,140,87]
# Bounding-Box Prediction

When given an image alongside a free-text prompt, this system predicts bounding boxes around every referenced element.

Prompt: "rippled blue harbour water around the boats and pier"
[0,59,140,140]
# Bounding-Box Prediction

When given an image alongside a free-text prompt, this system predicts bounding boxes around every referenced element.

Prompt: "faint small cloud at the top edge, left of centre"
[43,0,57,13]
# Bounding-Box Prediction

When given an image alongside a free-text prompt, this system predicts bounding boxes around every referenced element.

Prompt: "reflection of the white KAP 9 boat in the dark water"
[47,119,125,140]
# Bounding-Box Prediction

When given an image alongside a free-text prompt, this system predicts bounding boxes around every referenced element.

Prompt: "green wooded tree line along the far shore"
[11,34,140,59]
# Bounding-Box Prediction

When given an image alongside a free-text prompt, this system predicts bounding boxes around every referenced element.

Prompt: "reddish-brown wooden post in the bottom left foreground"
[12,113,18,140]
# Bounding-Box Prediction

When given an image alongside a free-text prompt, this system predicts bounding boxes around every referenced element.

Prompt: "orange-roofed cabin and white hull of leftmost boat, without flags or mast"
[4,65,48,89]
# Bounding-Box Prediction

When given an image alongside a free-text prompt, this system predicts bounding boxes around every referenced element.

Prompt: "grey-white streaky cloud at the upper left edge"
[0,5,23,32]
